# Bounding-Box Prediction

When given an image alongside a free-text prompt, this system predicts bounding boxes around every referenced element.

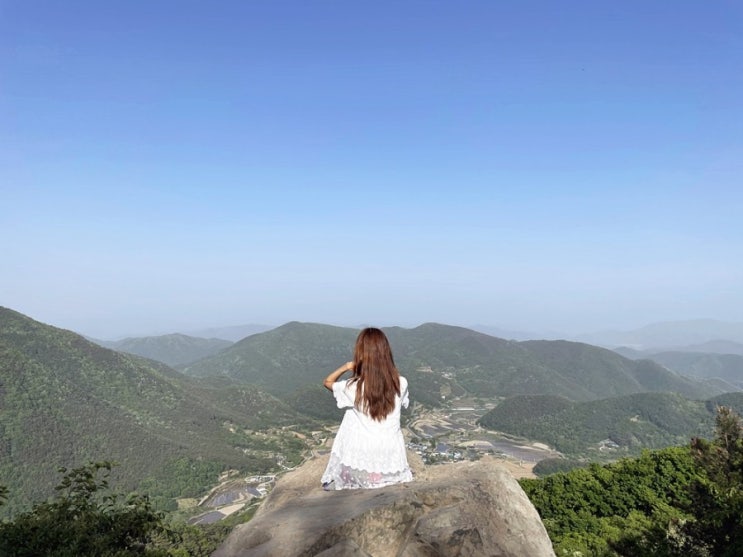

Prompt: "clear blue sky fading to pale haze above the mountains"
[0,0,743,338]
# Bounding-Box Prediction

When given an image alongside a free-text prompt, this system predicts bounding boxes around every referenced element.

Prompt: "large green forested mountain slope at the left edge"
[0,308,307,514]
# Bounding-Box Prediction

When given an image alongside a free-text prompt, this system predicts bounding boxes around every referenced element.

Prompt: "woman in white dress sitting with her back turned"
[322,327,413,490]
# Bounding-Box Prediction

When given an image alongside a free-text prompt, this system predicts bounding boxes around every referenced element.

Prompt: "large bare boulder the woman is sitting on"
[213,455,554,557]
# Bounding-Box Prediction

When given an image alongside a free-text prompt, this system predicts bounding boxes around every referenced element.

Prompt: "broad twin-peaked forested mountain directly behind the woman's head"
[180,322,723,405]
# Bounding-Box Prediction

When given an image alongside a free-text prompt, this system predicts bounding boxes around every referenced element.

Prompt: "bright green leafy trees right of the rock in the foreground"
[520,406,743,557]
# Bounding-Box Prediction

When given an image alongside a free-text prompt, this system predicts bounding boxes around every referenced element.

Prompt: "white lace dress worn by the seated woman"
[322,377,413,490]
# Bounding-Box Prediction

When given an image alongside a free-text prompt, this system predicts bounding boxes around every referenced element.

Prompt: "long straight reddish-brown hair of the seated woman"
[351,327,400,421]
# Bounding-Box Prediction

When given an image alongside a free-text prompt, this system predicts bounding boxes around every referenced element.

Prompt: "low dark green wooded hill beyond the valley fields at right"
[479,393,743,458]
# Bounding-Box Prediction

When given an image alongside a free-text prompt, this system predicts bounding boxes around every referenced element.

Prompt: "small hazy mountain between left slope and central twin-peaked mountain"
[95,333,232,366]
